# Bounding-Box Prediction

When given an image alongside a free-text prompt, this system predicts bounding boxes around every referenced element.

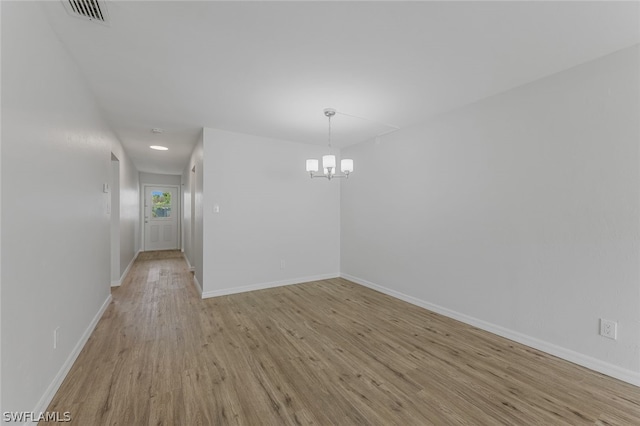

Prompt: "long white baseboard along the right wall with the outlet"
[340,273,640,386]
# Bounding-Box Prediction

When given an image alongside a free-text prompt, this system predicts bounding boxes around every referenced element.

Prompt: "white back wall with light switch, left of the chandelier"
[202,129,340,297]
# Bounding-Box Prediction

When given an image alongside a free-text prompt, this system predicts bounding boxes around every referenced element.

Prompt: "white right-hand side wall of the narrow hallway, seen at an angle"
[182,134,203,293]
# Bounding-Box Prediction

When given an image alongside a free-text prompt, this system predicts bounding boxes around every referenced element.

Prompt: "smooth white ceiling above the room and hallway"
[43,1,640,174]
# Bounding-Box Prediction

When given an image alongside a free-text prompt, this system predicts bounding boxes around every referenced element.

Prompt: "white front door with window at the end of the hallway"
[144,186,180,251]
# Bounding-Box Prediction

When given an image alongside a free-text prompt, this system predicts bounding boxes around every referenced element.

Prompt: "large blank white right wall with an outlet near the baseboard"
[342,46,640,384]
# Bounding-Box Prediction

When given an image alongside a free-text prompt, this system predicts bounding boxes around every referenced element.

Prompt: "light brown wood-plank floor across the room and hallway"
[49,252,640,426]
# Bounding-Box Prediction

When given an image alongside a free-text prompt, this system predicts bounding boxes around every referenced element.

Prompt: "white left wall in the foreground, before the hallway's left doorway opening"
[0,2,138,411]
